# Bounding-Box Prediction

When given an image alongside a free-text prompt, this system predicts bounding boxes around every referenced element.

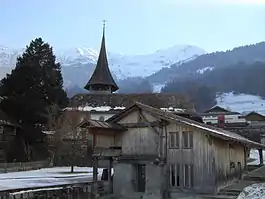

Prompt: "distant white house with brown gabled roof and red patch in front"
[200,106,247,127]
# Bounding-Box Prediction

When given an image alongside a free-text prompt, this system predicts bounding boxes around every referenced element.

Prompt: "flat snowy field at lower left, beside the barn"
[0,167,107,191]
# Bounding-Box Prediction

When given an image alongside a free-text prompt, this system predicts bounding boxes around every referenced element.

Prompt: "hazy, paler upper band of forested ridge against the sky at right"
[148,42,265,83]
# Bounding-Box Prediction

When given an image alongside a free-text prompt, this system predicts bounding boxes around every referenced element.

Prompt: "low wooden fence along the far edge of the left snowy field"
[0,160,52,173]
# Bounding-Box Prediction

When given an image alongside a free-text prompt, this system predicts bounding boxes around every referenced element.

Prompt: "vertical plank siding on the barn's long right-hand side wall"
[167,124,244,193]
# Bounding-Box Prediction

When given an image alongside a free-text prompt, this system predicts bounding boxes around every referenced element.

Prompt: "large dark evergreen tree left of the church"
[0,38,68,126]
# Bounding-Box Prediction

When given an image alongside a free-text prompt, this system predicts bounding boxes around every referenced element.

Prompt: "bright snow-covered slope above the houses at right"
[216,92,265,115]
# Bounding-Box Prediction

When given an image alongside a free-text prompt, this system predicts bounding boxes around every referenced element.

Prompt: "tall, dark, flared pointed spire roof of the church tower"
[85,25,119,92]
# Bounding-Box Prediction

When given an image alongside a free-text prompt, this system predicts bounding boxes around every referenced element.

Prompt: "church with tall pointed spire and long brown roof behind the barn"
[65,24,195,121]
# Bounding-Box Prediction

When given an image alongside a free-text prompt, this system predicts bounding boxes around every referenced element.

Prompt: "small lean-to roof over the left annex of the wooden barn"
[78,119,126,130]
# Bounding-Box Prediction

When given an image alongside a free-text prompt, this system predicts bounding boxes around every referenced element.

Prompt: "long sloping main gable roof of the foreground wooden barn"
[106,102,265,148]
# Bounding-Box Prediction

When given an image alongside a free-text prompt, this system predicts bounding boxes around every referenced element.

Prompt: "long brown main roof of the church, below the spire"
[70,93,194,112]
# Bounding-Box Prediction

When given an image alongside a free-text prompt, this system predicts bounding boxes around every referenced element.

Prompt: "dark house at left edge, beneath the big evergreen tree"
[0,110,21,163]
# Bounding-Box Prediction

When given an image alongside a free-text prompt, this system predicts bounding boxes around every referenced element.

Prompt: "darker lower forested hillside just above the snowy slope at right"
[162,61,265,111]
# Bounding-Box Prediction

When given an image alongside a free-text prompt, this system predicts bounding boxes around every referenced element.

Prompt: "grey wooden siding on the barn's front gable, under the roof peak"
[116,111,159,155]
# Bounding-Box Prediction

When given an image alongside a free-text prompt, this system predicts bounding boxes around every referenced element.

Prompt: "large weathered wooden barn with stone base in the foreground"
[80,102,265,198]
